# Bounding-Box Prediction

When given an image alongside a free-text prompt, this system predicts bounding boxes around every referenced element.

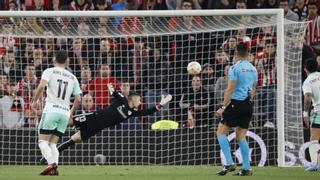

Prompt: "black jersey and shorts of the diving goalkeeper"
[75,91,158,140]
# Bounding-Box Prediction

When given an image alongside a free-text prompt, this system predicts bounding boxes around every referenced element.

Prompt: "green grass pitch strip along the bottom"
[0,165,320,180]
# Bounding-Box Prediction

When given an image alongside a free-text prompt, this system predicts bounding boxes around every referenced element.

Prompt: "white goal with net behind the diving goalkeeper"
[0,10,306,166]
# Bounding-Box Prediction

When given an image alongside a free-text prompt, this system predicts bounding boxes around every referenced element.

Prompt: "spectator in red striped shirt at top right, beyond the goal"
[306,1,320,55]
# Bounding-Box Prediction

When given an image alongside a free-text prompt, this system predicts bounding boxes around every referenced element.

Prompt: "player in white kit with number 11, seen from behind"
[31,51,81,175]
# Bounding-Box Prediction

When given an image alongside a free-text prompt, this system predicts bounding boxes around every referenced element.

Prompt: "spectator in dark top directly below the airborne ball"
[179,76,210,128]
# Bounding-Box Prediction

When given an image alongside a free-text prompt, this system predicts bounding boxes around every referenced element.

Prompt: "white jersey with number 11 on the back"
[41,67,81,116]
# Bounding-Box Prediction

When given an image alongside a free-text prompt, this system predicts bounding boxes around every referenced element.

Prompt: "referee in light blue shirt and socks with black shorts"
[216,43,258,176]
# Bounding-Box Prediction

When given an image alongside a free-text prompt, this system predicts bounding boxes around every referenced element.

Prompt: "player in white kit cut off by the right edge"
[302,59,320,171]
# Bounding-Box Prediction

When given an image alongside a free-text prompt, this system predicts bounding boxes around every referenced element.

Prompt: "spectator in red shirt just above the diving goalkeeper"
[89,64,120,109]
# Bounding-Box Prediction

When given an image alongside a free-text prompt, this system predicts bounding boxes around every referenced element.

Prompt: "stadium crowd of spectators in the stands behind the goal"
[0,0,320,131]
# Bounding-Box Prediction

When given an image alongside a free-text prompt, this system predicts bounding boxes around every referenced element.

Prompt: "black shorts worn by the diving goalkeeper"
[74,113,102,141]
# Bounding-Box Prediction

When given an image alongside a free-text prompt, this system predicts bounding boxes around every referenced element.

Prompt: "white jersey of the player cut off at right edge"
[302,72,320,112]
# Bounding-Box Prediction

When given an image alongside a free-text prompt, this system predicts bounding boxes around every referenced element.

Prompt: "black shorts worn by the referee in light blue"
[220,98,253,129]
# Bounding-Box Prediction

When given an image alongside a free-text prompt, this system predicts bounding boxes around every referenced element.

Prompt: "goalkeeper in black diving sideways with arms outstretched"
[41,84,172,162]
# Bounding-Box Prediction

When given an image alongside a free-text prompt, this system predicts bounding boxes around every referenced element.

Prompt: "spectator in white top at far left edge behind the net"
[0,82,24,128]
